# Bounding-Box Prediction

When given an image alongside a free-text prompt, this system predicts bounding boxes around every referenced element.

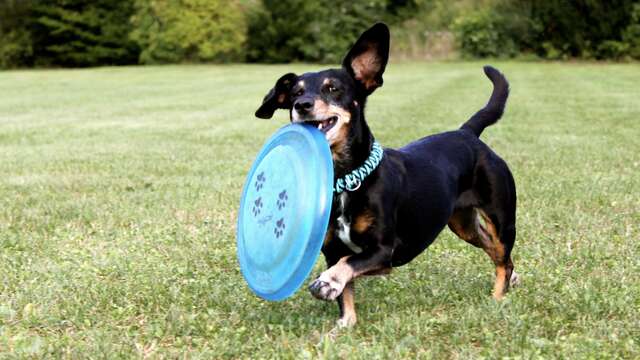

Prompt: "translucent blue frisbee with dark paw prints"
[236,124,333,301]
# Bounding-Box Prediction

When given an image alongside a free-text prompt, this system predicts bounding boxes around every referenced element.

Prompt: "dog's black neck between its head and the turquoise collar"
[333,109,374,180]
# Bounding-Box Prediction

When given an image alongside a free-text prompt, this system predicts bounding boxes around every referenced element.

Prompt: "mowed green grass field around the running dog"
[0,63,640,359]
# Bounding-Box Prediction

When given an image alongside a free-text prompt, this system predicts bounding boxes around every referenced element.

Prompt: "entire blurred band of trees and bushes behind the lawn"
[0,0,640,68]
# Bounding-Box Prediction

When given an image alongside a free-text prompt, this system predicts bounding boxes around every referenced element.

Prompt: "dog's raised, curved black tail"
[460,65,509,137]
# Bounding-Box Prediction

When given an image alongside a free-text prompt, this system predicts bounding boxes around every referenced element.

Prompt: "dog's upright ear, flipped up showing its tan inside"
[342,23,389,94]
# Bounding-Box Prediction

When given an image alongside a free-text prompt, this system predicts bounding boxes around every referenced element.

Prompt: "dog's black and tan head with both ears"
[256,23,389,150]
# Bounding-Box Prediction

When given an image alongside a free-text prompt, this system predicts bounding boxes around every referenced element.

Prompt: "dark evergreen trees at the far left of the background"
[0,0,139,67]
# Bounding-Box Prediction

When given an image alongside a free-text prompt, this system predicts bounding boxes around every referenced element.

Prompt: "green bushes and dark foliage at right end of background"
[453,0,639,59]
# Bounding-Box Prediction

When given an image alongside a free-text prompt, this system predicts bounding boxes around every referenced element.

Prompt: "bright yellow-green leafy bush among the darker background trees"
[131,0,246,64]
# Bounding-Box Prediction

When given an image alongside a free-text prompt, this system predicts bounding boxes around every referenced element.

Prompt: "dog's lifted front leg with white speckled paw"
[309,246,392,300]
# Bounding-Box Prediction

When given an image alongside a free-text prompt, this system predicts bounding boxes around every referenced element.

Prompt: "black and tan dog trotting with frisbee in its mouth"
[256,24,517,326]
